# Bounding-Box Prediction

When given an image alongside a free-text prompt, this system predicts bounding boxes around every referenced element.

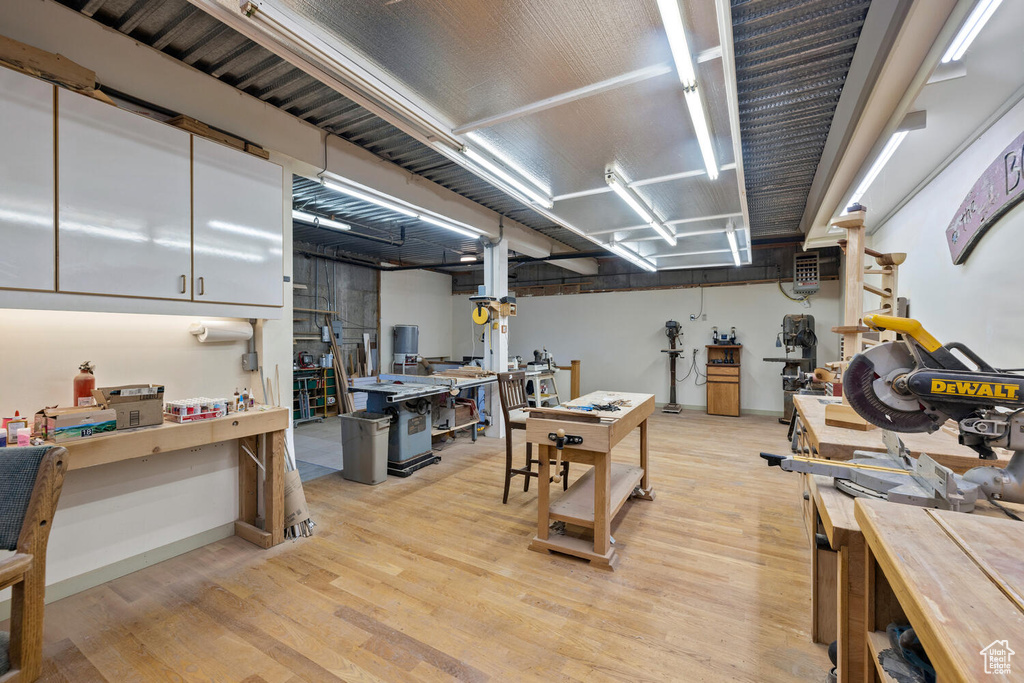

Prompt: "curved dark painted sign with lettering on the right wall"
[946,133,1024,265]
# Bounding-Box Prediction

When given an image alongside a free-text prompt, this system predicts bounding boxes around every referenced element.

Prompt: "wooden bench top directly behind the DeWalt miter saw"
[793,395,1010,474]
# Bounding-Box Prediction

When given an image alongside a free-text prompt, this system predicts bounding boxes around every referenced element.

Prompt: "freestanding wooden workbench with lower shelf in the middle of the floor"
[526,391,654,569]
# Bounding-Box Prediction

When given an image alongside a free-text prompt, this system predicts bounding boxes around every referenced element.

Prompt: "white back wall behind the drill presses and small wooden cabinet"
[453,282,839,415]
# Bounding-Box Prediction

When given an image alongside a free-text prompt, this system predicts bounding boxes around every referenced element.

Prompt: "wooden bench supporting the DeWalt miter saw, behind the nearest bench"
[801,474,1024,683]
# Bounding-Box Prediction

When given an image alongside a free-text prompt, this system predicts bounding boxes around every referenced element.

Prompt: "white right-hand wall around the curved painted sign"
[872,94,1024,368]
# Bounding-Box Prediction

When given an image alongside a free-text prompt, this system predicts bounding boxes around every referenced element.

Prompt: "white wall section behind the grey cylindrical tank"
[380,270,452,372]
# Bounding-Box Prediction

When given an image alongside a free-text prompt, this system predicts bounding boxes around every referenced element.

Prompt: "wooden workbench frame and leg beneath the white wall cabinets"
[55,408,289,548]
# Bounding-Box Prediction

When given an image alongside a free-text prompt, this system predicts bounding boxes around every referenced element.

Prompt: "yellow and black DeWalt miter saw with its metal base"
[762,315,1024,512]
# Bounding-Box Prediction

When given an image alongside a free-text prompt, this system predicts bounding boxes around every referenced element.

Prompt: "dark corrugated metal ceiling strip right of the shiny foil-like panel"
[732,0,870,237]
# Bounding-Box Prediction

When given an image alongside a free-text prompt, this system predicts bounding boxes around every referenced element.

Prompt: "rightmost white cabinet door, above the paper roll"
[193,137,285,306]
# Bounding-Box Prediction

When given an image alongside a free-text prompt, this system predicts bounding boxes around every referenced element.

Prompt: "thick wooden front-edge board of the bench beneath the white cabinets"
[57,408,289,470]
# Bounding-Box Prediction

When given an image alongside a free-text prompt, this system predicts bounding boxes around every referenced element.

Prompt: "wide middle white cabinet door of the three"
[57,89,191,299]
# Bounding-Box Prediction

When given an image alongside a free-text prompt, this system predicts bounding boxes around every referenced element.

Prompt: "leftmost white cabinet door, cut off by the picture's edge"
[0,67,55,292]
